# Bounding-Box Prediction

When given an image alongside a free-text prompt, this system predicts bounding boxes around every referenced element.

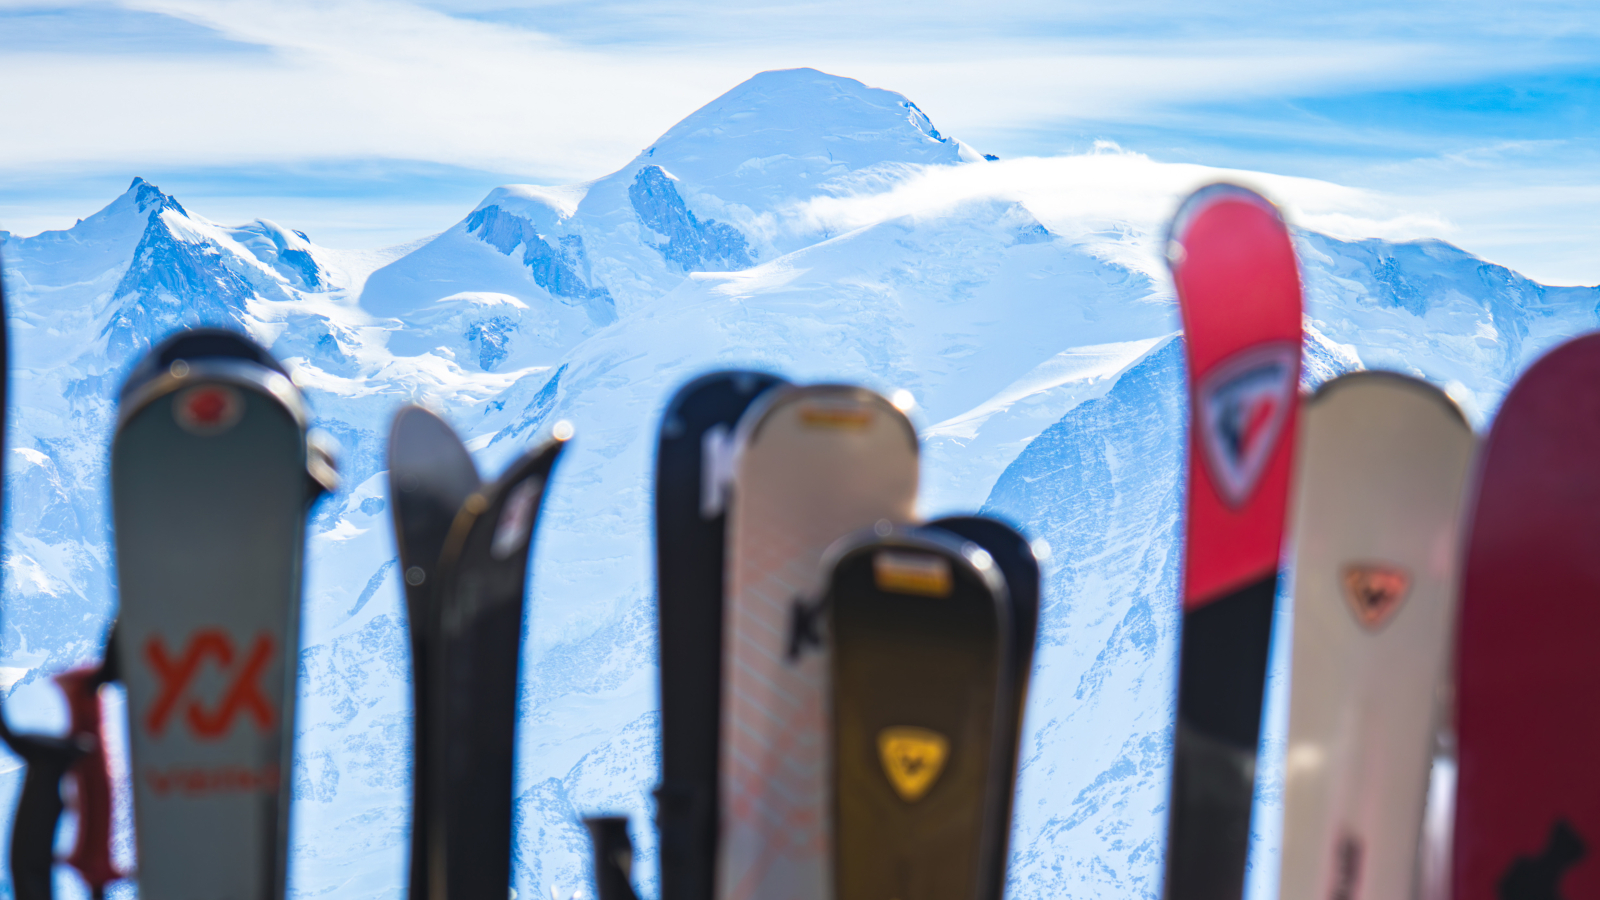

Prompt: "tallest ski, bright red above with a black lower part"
[1165,184,1301,900]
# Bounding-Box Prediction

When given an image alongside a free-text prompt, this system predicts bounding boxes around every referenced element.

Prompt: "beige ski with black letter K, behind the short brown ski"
[715,386,917,900]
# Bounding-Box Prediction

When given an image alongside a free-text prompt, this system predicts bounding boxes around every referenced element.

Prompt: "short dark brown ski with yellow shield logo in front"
[824,525,1014,900]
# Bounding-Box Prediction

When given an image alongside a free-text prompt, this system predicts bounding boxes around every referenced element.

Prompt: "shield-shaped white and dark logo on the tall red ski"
[1195,343,1299,509]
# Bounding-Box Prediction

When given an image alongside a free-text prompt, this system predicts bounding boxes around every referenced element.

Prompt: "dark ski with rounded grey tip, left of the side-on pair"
[389,405,482,900]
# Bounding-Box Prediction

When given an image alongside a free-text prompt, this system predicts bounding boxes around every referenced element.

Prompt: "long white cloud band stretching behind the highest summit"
[0,0,1574,179]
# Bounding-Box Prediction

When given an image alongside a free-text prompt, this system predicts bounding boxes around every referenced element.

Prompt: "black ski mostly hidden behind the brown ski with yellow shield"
[928,516,1038,900]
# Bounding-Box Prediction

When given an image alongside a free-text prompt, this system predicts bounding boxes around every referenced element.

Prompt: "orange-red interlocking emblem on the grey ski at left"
[144,628,277,740]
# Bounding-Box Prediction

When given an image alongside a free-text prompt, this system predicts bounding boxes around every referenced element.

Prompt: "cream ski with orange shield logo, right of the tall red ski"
[1278,372,1474,900]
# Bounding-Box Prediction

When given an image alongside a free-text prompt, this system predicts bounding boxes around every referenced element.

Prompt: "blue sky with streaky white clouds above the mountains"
[0,0,1600,285]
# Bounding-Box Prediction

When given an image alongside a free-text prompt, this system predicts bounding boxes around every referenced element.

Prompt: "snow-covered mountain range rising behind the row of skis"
[0,69,1600,900]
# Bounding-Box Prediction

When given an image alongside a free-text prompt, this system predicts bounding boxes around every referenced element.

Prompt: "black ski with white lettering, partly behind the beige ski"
[656,372,781,900]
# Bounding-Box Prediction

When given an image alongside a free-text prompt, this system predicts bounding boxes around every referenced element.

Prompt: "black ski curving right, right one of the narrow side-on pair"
[419,423,571,900]
